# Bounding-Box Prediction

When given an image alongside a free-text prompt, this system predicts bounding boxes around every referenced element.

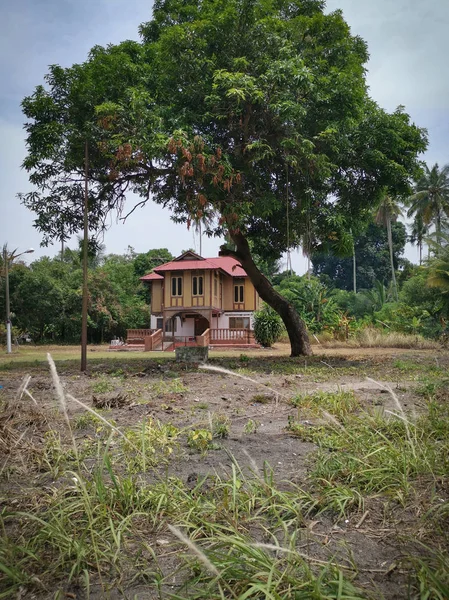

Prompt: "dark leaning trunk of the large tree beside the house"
[220,232,312,356]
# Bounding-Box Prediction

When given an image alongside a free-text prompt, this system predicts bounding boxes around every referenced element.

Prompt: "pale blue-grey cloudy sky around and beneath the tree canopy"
[0,0,449,273]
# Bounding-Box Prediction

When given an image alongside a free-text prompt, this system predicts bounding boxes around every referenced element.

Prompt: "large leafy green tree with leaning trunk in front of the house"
[23,0,426,356]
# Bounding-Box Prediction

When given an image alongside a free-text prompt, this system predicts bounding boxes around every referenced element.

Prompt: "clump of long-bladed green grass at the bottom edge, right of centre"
[170,525,366,600]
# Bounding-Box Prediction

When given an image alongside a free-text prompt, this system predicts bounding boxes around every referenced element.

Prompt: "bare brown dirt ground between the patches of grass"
[0,348,449,600]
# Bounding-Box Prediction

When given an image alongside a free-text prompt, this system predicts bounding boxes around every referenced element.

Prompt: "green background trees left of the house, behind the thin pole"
[0,248,165,343]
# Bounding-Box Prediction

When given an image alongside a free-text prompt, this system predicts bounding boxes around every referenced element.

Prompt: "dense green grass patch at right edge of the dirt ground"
[296,404,449,504]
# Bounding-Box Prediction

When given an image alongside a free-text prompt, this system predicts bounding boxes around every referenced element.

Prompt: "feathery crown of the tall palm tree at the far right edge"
[407,163,449,243]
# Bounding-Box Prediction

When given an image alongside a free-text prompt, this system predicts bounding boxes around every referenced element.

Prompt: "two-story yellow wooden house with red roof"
[141,251,261,344]
